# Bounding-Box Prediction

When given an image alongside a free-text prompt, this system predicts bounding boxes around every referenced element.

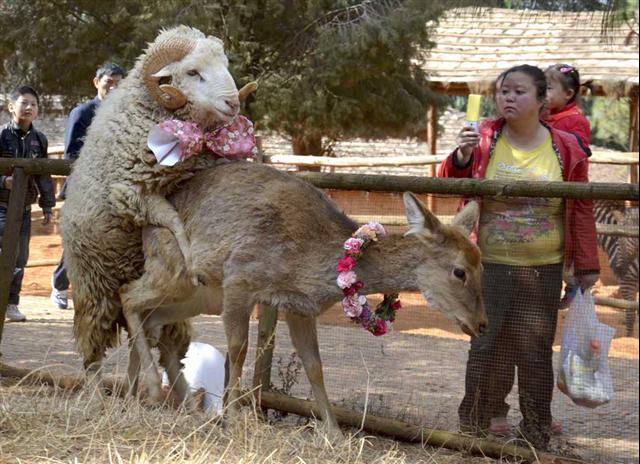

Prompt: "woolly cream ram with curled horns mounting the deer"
[60,26,254,402]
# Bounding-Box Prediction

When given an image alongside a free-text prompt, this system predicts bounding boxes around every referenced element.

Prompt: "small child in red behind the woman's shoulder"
[545,63,591,147]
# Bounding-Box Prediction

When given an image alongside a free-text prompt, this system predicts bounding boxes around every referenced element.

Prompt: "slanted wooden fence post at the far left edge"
[0,167,27,354]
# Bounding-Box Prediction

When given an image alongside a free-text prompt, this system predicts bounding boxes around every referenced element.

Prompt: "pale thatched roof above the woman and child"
[422,8,638,96]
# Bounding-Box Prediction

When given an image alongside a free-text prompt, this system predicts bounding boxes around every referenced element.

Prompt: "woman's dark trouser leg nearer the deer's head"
[458,263,514,431]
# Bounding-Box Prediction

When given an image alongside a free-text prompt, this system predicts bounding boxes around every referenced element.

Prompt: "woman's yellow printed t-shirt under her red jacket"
[478,136,564,266]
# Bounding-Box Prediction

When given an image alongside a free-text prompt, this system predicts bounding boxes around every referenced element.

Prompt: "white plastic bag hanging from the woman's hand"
[557,291,615,408]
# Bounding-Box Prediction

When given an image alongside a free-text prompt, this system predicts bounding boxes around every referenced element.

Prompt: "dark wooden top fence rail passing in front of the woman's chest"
[294,172,640,201]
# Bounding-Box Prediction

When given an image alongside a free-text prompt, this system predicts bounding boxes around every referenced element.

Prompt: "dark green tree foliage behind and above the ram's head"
[0,0,636,145]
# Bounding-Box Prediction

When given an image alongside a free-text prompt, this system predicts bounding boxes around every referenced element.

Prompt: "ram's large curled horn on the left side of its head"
[142,38,195,110]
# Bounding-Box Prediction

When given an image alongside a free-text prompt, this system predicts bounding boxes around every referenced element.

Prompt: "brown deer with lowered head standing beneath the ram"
[120,161,487,437]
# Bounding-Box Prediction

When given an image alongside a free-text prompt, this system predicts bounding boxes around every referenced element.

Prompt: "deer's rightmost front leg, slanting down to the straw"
[286,313,342,441]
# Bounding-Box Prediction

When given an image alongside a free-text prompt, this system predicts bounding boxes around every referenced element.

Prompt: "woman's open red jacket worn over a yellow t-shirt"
[438,119,600,274]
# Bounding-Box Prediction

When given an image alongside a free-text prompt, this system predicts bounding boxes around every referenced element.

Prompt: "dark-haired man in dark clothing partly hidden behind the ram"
[51,63,124,309]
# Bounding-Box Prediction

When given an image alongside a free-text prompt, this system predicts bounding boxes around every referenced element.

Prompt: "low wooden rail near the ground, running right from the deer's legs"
[261,391,580,464]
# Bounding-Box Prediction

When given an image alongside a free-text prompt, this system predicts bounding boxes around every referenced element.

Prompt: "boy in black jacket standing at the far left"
[0,85,56,322]
